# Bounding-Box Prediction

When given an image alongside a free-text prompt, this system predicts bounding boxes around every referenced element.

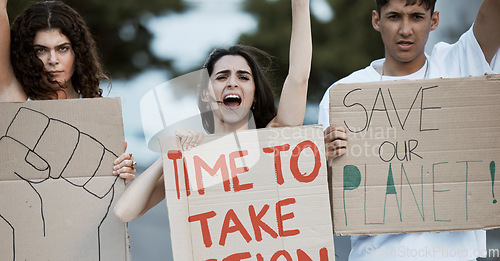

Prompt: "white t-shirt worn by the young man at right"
[318,24,500,261]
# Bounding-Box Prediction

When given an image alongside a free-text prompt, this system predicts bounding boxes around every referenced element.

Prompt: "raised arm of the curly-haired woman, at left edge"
[0,0,26,102]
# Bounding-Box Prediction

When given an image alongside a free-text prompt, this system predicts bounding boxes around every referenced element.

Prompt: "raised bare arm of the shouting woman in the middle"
[269,0,312,126]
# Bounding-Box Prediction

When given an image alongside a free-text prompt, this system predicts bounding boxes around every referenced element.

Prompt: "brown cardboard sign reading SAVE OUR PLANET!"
[330,75,500,234]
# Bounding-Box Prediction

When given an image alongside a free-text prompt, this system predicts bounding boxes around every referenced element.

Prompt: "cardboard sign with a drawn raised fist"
[0,98,129,261]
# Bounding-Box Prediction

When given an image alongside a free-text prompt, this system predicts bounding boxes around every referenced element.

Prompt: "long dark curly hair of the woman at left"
[10,1,109,100]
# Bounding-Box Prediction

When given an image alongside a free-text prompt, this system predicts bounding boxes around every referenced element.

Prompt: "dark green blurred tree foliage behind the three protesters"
[7,0,383,102]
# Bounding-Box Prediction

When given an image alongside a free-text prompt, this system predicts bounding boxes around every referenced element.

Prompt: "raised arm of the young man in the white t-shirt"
[473,0,500,62]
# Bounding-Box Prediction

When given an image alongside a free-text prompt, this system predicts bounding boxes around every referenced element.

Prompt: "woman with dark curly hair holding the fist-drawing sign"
[0,0,135,183]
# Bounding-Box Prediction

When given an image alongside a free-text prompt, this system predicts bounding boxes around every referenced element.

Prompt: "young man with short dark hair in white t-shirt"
[318,0,500,260]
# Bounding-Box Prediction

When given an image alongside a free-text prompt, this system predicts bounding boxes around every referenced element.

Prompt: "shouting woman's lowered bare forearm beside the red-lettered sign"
[114,158,165,222]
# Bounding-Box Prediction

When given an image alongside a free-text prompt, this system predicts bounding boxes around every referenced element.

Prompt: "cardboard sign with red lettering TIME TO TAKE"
[160,126,335,261]
